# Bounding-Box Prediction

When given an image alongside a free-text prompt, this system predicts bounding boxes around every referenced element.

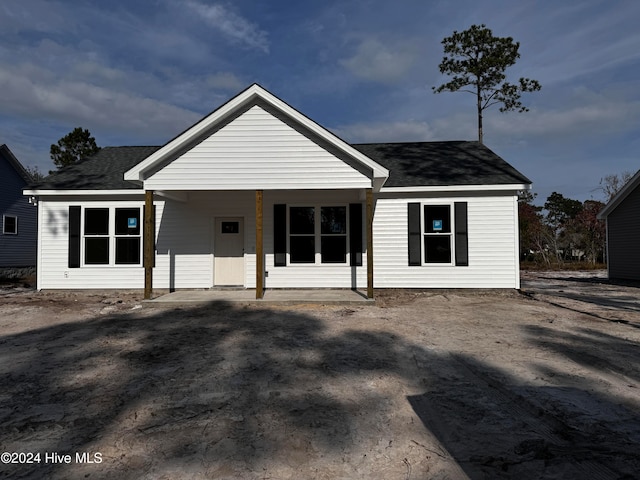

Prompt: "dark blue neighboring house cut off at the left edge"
[0,145,37,268]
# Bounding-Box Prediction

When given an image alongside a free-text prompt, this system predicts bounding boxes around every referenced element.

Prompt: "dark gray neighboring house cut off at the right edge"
[598,170,640,281]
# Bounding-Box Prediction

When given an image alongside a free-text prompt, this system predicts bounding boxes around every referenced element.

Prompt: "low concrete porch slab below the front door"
[143,289,374,307]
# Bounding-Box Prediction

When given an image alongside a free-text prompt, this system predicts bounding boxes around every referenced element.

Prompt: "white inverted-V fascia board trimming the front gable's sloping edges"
[124,84,389,183]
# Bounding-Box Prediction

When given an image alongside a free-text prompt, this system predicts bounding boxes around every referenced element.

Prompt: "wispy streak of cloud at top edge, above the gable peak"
[186,0,269,53]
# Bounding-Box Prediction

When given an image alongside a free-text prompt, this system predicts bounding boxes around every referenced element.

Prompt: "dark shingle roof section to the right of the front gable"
[352,141,531,187]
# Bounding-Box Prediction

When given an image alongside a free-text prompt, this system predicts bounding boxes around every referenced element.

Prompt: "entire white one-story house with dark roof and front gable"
[26,84,531,298]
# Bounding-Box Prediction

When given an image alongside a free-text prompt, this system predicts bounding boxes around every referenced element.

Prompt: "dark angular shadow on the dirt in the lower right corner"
[407,348,640,480]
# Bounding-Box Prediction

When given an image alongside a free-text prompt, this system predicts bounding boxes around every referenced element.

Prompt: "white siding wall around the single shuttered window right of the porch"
[373,195,520,288]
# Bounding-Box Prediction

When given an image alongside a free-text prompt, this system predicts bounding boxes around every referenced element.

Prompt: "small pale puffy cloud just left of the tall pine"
[340,38,417,84]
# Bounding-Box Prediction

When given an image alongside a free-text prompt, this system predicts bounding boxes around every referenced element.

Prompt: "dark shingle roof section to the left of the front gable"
[32,147,160,190]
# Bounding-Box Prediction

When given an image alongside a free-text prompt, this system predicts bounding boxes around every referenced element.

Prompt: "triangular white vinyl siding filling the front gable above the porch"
[145,106,371,190]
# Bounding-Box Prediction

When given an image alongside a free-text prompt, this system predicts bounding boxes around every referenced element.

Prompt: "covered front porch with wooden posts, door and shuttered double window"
[143,188,374,299]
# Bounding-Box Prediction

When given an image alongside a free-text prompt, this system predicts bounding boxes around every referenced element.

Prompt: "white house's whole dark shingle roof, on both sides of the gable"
[32,141,531,190]
